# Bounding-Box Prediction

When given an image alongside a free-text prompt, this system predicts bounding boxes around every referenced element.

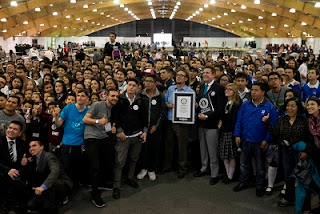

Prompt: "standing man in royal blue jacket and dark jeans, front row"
[233,83,277,197]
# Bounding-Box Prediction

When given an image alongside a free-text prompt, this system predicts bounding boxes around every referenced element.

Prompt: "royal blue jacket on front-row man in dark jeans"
[234,100,278,143]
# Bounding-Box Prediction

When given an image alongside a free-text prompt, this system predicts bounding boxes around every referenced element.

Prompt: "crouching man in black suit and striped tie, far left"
[0,121,28,213]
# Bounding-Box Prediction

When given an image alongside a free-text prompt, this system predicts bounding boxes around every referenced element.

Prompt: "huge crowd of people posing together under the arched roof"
[0,33,320,213]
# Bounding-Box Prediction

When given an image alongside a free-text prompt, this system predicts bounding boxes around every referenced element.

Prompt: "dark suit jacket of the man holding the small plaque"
[197,81,227,129]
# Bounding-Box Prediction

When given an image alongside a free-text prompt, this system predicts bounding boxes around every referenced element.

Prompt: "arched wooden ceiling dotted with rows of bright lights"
[0,0,320,39]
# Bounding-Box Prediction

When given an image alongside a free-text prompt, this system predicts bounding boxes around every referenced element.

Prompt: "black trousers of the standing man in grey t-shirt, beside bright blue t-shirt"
[85,137,114,192]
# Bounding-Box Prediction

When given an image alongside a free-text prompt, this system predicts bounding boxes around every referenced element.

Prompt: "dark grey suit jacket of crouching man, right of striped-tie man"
[32,151,72,189]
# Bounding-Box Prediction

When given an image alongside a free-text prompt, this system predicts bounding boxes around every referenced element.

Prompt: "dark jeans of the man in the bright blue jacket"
[240,140,265,189]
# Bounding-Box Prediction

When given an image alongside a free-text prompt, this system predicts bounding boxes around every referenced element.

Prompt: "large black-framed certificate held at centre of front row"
[172,91,196,124]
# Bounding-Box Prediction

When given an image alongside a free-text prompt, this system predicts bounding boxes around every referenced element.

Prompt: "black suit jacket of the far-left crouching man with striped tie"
[0,136,29,177]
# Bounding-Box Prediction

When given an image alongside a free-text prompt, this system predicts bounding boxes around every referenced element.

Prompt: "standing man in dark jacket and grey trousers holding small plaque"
[194,67,226,185]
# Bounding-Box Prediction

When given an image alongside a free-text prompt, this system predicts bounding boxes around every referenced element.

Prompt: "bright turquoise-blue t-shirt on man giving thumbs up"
[60,104,88,146]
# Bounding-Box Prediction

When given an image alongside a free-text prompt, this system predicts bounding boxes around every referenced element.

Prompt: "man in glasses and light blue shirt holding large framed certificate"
[162,70,194,179]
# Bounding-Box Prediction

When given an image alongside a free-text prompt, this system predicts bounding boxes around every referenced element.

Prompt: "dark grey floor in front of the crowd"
[63,172,304,214]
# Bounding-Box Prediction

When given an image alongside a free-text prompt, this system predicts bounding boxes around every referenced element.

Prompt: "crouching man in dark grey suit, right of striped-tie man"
[28,140,72,213]
